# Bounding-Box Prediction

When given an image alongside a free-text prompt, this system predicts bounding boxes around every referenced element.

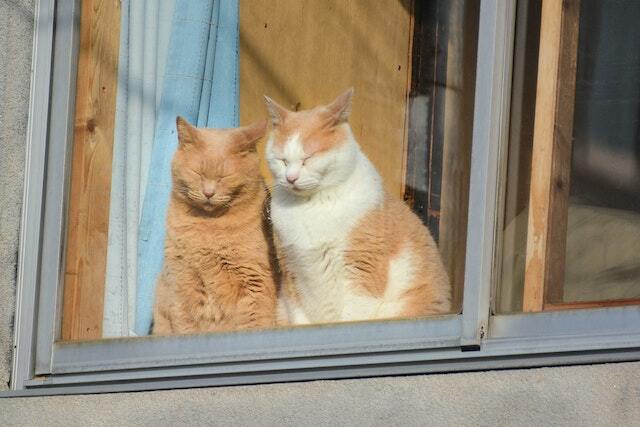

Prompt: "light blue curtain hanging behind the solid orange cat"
[135,0,239,335]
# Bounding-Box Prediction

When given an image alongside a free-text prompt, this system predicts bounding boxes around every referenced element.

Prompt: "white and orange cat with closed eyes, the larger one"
[265,89,451,324]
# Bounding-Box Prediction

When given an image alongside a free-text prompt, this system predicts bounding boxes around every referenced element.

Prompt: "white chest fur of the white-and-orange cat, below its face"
[271,153,384,323]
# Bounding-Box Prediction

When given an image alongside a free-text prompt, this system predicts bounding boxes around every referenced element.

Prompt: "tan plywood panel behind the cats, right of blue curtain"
[240,0,412,196]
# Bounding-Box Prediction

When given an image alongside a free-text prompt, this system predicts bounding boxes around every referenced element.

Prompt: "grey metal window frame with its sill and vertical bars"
[5,0,640,395]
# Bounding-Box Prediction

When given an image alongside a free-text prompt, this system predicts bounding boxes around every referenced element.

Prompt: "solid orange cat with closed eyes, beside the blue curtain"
[153,117,276,334]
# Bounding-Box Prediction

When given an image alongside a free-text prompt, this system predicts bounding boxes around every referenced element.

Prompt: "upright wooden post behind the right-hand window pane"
[523,0,580,312]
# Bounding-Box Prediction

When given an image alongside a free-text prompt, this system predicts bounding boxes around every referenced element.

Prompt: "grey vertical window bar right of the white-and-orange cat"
[461,0,516,347]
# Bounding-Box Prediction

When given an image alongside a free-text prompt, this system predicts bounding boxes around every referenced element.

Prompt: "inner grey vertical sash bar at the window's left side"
[35,1,80,375]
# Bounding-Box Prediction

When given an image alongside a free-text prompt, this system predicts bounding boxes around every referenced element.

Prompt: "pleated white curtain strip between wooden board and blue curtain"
[103,0,174,337]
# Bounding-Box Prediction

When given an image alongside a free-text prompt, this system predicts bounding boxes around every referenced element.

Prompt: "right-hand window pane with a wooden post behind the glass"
[496,0,640,312]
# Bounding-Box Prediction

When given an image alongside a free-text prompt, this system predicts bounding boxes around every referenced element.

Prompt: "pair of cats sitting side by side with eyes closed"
[153,89,451,334]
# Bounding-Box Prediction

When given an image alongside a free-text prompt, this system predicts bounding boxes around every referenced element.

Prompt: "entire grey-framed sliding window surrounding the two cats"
[12,0,640,393]
